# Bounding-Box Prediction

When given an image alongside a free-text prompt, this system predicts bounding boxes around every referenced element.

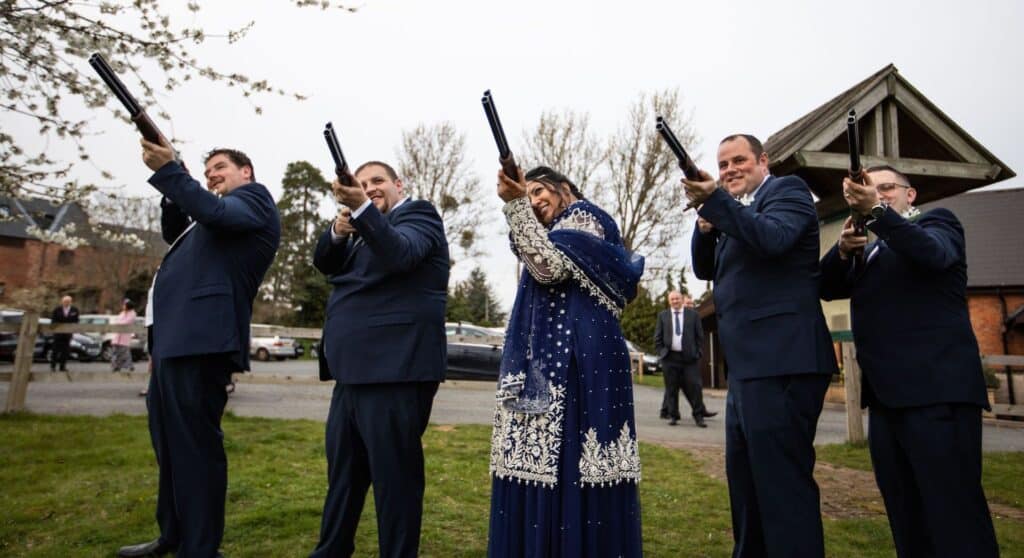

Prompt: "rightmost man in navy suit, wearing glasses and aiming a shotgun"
[821,166,998,558]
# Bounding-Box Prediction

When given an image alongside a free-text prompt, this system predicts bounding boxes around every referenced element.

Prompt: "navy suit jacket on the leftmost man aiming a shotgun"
[150,162,281,370]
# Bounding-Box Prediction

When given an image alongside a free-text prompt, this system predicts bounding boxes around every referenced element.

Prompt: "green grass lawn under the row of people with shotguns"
[0,415,1024,558]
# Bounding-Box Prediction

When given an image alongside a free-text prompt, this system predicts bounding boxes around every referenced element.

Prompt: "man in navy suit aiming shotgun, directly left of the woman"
[311,161,451,558]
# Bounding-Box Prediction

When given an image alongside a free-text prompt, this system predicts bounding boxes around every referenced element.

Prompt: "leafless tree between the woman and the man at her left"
[398,122,489,257]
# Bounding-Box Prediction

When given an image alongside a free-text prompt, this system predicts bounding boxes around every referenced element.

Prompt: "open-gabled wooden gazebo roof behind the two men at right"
[765,65,1016,217]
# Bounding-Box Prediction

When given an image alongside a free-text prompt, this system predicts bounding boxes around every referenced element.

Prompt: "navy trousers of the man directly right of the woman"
[725,374,830,558]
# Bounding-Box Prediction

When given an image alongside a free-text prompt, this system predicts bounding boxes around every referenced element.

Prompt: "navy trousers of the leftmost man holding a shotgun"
[146,355,231,558]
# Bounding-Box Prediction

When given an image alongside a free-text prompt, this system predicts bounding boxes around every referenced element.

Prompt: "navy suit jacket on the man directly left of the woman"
[313,200,451,384]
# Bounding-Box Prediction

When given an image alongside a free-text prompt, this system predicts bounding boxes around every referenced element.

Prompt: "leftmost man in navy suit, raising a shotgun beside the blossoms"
[118,139,281,557]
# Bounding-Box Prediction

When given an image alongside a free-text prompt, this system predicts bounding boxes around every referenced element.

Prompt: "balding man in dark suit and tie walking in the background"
[654,291,717,428]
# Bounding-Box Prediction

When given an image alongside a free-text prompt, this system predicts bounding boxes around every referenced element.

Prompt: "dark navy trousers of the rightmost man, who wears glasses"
[868,404,999,558]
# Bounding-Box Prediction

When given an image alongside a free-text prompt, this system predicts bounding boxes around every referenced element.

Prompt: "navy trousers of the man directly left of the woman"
[310,382,438,558]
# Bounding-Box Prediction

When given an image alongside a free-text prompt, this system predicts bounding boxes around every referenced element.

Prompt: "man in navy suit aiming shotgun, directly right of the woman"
[683,135,837,558]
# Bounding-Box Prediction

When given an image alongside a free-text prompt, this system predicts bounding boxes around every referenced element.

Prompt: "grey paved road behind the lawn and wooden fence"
[6,360,1024,452]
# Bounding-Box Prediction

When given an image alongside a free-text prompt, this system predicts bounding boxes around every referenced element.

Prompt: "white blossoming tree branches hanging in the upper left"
[0,0,353,208]
